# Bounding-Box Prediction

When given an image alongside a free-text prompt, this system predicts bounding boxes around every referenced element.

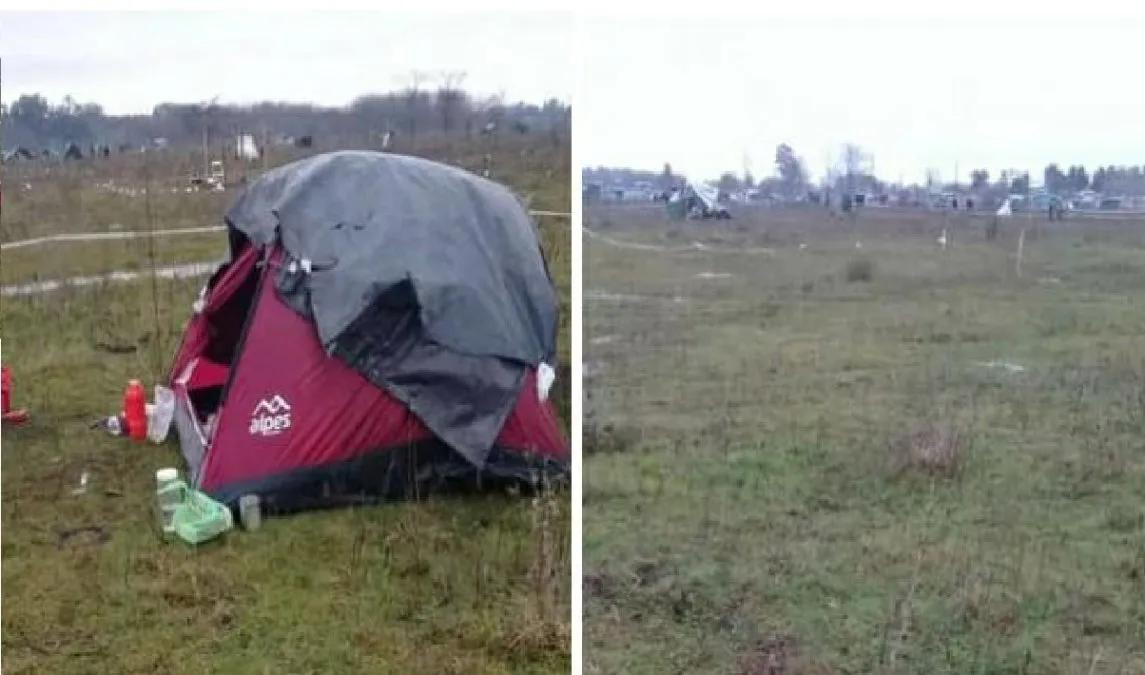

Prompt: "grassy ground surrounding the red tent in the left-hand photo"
[0,137,570,674]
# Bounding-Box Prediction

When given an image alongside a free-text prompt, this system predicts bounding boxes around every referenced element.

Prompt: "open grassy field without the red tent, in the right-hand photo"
[583,207,1145,675]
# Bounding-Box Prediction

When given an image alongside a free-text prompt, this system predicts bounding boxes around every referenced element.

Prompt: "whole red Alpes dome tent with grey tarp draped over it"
[171,152,569,513]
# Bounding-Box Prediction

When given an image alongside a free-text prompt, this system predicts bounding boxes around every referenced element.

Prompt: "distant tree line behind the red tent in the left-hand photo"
[0,85,570,152]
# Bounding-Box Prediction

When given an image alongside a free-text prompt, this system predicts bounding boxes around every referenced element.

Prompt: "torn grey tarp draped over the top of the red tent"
[227,151,558,467]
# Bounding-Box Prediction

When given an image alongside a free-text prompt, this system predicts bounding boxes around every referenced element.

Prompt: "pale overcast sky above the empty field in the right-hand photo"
[575,13,1145,182]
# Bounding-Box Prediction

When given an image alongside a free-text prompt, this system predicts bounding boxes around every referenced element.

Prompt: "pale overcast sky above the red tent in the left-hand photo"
[0,11,574,113]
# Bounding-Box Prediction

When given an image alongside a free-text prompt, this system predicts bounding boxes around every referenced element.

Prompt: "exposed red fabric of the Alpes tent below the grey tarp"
[171,152,569,511]
